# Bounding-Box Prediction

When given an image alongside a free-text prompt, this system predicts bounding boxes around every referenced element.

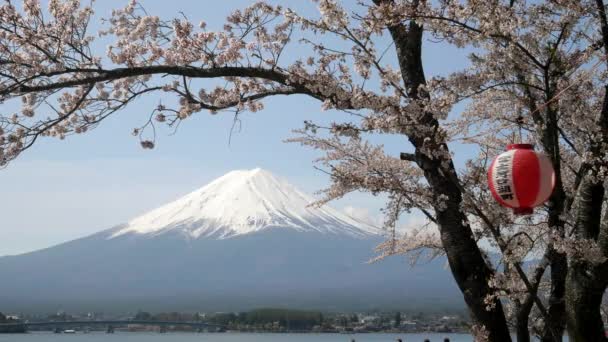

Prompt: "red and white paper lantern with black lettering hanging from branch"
[488,144,555,215]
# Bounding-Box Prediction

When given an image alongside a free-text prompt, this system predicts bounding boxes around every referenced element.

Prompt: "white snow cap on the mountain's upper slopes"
[109,168,380,239]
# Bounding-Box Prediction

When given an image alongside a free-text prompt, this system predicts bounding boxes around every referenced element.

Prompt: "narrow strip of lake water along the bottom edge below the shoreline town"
[0,332,473,342]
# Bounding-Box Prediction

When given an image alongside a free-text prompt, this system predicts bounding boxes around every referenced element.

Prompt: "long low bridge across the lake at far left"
[0,320,225,332]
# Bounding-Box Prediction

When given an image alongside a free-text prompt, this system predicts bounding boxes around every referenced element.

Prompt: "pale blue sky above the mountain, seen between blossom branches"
[0,0,470,255]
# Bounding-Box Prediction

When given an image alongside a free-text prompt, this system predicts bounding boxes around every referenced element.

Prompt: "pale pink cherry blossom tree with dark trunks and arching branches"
[0,0,608,341]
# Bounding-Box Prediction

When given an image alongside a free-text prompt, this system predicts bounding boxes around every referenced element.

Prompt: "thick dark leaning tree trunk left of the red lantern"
[373,0,511,336]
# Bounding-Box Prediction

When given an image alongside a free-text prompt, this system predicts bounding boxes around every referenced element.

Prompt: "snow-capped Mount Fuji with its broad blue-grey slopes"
[0,169,463,312]
